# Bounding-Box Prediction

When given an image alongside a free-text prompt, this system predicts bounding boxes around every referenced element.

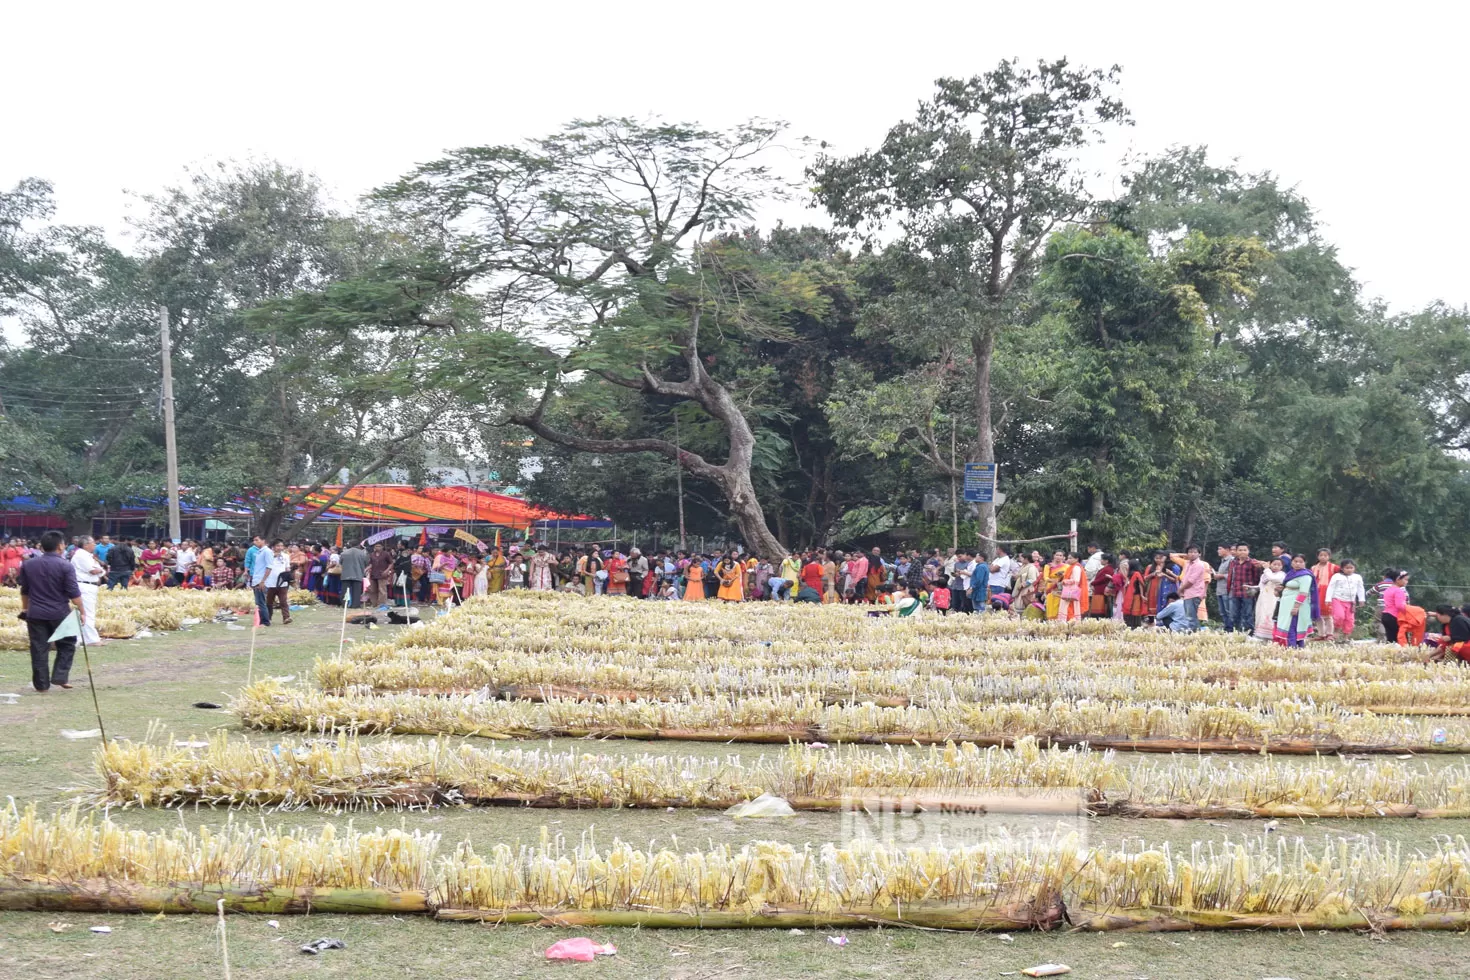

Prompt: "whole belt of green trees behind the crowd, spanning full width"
[0,60,1470,590]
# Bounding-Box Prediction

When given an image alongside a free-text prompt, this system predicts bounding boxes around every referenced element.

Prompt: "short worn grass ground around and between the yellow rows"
[0,610,1470,980]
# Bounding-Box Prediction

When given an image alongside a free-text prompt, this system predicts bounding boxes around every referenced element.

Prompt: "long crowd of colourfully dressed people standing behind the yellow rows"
[11,535,1470,658]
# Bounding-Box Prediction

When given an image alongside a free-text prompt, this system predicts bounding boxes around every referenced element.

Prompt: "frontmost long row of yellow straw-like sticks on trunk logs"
[0,805,1470,930]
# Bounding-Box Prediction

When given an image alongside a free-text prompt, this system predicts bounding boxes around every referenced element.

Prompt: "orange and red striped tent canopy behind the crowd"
[286,483,612,530]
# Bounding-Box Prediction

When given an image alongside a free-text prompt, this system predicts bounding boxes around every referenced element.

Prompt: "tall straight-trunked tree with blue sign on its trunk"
[811,59,1127,548]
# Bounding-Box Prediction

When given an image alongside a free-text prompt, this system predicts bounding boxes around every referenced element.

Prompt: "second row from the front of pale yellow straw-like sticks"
[97,733,1470,818]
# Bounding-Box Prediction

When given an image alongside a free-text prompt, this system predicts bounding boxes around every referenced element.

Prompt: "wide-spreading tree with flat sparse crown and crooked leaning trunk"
[378,119,816,554]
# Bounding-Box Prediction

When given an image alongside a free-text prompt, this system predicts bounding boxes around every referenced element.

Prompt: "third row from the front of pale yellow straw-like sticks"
[232,680,1470,754]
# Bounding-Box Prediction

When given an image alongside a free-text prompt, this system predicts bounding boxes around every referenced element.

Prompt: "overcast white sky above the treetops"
[0,0,1470,310]
